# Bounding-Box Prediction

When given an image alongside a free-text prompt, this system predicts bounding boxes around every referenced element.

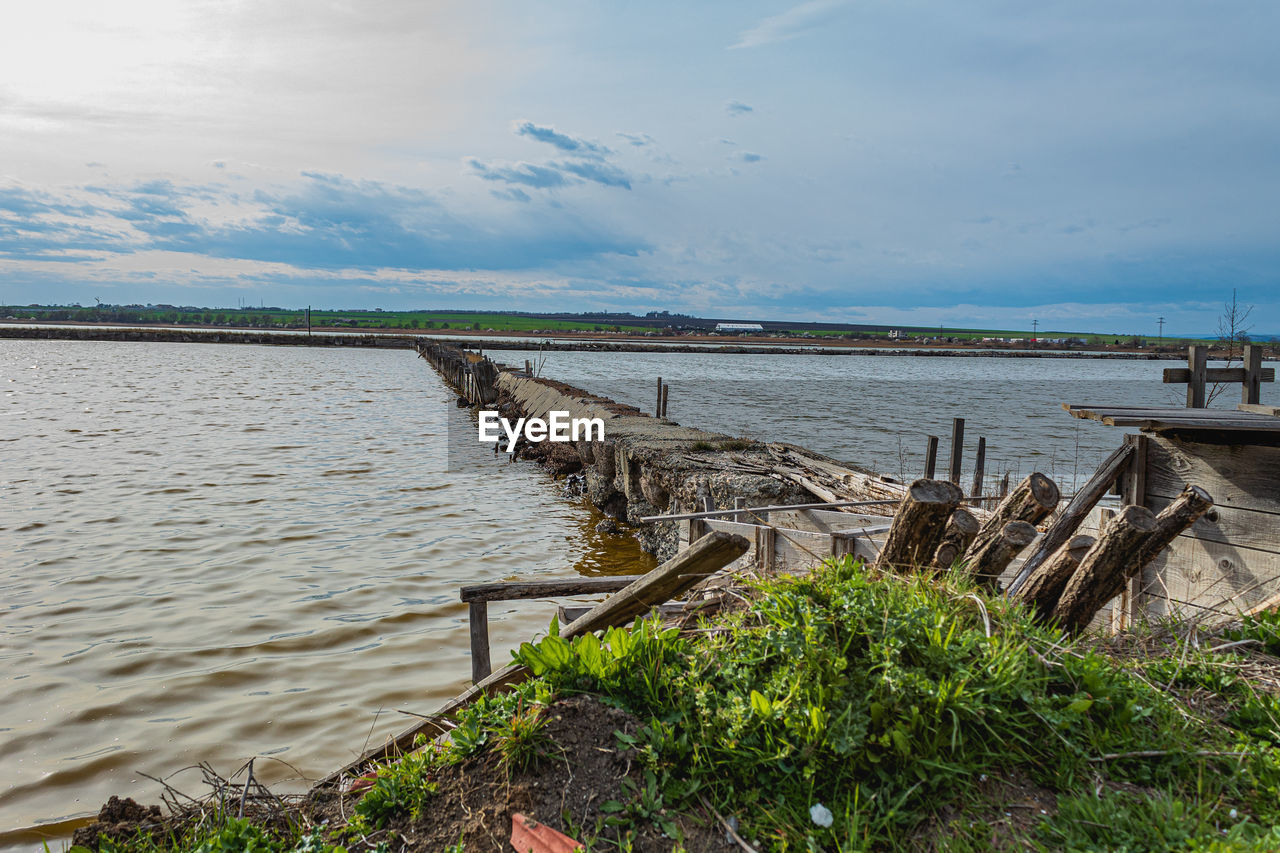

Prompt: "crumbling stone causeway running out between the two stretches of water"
[419,342,904,560]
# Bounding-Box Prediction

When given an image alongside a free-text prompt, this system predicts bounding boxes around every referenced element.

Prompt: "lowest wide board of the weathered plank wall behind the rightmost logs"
[1142,537,1280,617]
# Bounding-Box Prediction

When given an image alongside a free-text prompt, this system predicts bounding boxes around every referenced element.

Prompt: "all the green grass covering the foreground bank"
[72,558,1280,853]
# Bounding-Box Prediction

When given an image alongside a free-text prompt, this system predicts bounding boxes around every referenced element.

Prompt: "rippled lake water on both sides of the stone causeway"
[0,341,1275,849]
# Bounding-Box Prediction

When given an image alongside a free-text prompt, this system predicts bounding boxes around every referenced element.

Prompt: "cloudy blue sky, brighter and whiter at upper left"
[0,0,1280,334]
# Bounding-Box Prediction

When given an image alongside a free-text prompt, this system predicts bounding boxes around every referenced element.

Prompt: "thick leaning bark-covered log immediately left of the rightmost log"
[1050,506,1156,634]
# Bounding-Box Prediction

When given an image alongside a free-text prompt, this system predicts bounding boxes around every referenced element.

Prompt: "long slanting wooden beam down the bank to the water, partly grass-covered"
[316,532,749,788]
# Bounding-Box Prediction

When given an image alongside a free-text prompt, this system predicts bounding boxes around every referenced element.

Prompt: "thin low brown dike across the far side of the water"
[0,321,1239,361]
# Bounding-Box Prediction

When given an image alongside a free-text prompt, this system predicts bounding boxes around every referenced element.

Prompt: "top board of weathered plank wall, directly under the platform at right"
[1147,435,1280,514]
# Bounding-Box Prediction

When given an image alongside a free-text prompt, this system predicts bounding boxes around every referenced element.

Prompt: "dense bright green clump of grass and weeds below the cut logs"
[517,558,1280,850]
